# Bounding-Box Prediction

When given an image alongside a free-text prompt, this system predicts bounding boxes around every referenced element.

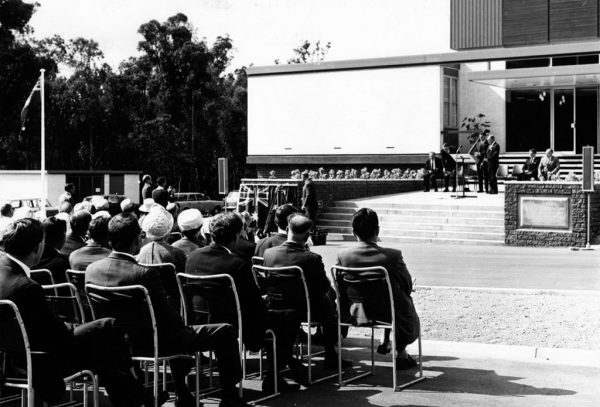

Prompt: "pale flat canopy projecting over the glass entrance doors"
[465,64,600,89]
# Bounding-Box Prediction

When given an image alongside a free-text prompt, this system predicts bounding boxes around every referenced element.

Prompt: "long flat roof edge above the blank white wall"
[247,39,600,76]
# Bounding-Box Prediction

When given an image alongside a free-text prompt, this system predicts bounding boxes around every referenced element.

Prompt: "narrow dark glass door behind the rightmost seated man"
[552,88,575,152]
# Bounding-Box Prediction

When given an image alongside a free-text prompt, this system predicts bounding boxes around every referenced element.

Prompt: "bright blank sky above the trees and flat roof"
[30,0,450,68]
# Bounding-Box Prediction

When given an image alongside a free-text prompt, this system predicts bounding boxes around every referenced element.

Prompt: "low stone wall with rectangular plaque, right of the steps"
[504,182,600,247]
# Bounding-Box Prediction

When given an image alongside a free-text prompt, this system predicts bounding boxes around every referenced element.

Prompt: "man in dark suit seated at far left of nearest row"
[0,218,154,407]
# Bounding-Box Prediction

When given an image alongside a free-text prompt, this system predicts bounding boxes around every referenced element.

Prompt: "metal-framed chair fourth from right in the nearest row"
[85,284,188,407]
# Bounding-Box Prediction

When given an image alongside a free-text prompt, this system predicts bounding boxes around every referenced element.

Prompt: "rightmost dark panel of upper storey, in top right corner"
[550,0,598,41]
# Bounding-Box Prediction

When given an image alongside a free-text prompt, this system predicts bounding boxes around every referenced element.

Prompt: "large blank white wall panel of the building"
[248,66,441,155]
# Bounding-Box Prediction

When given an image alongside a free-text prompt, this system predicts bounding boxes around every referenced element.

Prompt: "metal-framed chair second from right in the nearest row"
[252,265,337,385]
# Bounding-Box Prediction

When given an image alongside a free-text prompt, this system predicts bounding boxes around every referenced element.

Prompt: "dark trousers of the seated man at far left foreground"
[33,318,144,407]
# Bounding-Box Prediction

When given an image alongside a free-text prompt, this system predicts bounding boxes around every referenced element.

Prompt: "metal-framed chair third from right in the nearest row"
[177,273,280,404]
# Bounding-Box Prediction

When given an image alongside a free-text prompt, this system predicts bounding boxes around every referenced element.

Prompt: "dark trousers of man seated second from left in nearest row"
[164,324,242,397]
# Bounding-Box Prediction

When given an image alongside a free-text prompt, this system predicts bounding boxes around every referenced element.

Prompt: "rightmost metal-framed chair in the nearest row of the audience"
[331,266,426,391]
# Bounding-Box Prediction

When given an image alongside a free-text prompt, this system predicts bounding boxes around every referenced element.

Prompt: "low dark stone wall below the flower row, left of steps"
[242,178,423,208]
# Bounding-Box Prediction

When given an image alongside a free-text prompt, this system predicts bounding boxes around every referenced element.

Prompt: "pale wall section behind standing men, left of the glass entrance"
[458,62,506,152]
